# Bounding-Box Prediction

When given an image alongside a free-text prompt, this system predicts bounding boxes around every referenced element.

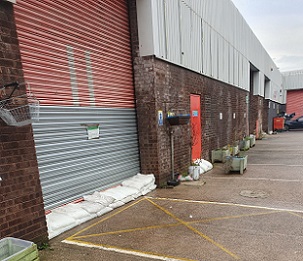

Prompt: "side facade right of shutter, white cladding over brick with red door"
[130,0,285,184]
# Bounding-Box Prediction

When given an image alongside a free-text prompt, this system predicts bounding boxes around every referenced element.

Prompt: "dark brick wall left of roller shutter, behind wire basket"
[0,1,48,243]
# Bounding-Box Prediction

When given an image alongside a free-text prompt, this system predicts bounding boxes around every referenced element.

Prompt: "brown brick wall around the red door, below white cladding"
[129,0,248,185]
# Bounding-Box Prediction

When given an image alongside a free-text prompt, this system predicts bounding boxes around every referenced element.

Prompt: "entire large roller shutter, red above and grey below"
[15,0,139,209]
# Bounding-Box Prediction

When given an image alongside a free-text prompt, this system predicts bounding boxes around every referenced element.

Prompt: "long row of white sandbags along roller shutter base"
[46,173,156,239]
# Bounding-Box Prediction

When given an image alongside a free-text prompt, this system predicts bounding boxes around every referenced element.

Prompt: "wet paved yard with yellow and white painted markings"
[39,131,303,261]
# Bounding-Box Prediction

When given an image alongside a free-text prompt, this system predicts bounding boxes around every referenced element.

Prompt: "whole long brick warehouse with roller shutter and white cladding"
[0,0,292,241]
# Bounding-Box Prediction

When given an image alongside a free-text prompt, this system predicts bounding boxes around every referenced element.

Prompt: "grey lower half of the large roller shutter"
[33,106,140,209]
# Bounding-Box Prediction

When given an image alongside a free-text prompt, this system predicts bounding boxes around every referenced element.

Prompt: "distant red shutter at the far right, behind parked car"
[286,89,303,118]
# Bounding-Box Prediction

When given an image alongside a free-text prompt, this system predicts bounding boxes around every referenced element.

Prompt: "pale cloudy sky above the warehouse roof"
[232,0,303,72]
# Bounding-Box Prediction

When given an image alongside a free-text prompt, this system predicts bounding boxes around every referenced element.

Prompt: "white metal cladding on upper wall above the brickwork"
[137,0,282,101]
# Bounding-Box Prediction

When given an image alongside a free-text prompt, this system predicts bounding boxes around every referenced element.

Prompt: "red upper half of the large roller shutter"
[15,0,134,108]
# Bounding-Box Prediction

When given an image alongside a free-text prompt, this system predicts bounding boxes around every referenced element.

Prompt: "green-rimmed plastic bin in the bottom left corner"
[0,237,39,261]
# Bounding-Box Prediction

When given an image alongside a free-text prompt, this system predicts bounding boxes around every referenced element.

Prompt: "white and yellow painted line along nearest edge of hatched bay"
[62,239,198,261]
